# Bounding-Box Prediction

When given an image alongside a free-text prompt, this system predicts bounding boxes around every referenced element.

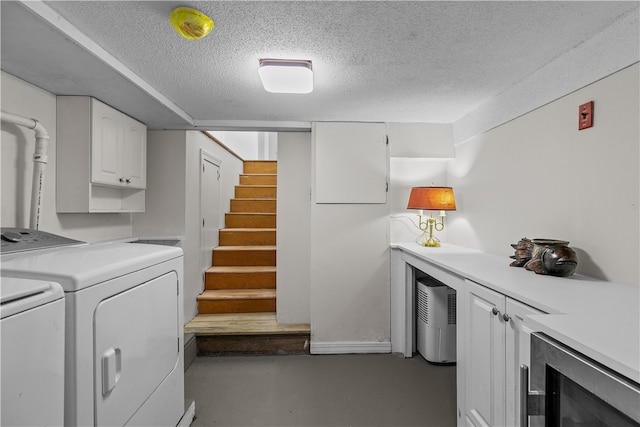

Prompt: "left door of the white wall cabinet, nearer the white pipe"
[92,99,123,185]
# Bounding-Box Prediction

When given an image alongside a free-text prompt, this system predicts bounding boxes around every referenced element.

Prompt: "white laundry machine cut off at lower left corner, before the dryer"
[0,278,64,426]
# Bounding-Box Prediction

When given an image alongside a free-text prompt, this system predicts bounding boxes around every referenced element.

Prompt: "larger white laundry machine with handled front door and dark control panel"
[1,229,185,426]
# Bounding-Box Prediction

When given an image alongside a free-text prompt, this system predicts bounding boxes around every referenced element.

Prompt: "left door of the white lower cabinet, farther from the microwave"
[465,281,505,426]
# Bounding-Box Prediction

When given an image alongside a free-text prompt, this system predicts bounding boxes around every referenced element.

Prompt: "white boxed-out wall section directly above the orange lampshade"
[387,123,454,159]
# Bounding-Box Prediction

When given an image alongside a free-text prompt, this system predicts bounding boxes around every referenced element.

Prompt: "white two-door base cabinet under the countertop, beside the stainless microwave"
[458,280,542,427]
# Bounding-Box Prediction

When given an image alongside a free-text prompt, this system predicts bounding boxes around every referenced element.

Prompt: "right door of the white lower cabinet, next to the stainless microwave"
[505,298,544,426]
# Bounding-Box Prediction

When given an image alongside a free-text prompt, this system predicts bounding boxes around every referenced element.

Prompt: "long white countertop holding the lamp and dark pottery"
[391,242,640,383]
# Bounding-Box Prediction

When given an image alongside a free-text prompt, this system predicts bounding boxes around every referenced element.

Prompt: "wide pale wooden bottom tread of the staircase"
[184,313,311,335]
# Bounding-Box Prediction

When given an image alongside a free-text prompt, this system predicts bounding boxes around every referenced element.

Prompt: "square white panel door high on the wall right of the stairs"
[313,122,388,203]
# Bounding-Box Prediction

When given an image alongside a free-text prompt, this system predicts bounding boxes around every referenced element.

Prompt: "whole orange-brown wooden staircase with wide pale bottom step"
[185,161,310,355]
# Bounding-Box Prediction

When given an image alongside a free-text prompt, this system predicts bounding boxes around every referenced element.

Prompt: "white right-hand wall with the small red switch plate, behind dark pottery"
[448,64,640,284]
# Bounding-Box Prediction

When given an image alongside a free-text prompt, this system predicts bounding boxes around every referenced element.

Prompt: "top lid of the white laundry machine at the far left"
[0,277,64,319]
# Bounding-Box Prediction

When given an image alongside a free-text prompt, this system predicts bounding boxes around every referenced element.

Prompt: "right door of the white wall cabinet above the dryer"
[122,116,147,188]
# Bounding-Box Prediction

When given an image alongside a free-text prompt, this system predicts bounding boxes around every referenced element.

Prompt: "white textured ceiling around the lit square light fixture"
[1,1,638,128]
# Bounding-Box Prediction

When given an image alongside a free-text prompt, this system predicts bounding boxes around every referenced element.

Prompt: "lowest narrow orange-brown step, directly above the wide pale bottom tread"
[197,289,276,314]
